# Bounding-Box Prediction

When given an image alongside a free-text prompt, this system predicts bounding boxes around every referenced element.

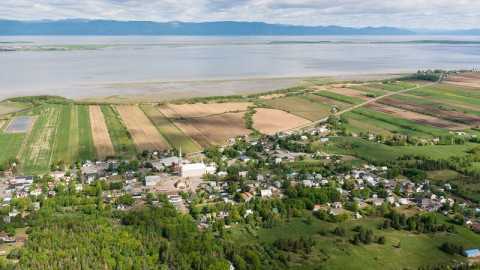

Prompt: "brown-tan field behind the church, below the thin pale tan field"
[187,112,252,142]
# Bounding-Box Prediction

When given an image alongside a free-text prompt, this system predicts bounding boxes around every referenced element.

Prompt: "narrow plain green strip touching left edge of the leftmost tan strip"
[77,105,95,160]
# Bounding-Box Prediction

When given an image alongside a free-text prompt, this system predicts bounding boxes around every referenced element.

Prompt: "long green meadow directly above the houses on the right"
[320,137,475,162]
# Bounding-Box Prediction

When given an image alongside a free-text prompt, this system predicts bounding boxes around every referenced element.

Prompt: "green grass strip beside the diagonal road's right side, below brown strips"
[345,112,432,138]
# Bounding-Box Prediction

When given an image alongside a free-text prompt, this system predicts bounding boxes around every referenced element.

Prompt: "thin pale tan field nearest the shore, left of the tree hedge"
[168,102,253,118]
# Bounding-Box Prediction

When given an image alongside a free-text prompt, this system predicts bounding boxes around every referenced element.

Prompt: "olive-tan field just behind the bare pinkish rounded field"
[263,97,331,121]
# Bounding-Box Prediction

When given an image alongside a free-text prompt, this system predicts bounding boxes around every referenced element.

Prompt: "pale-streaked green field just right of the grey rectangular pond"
[22,105,61,174]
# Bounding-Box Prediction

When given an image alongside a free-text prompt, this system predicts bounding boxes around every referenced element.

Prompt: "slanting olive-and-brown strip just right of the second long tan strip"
[140,105,201,153]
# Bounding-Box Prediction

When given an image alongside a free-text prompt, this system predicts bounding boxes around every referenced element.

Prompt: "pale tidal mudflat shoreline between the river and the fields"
[0,73,408,104]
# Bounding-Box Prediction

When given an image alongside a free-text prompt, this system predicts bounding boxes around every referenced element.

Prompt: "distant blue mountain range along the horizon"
[0,19,480,36]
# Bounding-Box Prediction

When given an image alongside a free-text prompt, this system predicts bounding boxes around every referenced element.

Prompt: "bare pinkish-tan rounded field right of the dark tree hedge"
[252,108,310,134]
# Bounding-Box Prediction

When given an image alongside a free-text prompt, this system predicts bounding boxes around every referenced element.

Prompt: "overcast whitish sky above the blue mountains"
[0,0,480,29]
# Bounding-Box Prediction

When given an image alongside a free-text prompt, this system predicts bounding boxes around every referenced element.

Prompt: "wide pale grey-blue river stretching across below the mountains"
[0,36,480,100]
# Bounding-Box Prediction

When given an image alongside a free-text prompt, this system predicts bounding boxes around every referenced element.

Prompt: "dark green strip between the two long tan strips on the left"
[102,105,136,157]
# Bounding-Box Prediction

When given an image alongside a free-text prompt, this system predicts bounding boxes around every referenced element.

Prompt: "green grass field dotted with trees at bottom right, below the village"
[230,213,479,269]
